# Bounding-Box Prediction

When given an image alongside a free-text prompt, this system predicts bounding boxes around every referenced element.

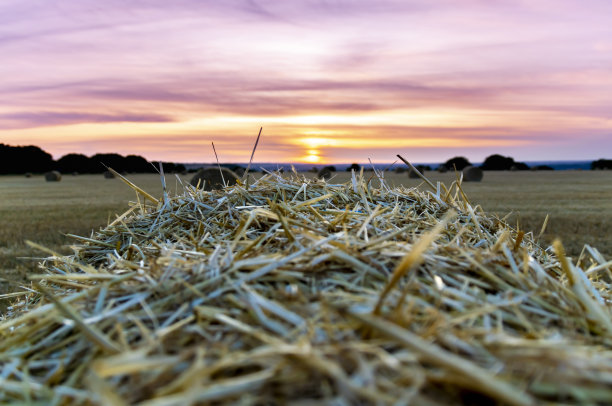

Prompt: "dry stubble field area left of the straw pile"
[0,175,184,302]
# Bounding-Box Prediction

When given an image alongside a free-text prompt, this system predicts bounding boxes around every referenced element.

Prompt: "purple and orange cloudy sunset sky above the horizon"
[0,0,612,164]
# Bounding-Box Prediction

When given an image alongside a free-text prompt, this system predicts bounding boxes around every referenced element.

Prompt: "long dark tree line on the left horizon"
[0,144,185,175]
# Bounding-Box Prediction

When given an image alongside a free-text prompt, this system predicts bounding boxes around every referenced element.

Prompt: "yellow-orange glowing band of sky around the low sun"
[0,109,609,164]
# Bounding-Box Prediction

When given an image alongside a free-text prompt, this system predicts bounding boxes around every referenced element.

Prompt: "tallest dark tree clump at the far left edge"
[0,144,54,174]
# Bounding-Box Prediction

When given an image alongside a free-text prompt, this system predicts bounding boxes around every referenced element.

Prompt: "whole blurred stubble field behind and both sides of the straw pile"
[0,171,612,311]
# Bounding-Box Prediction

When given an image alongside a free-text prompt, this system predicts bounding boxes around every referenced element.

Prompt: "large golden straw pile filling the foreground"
[0,172,612,405]
